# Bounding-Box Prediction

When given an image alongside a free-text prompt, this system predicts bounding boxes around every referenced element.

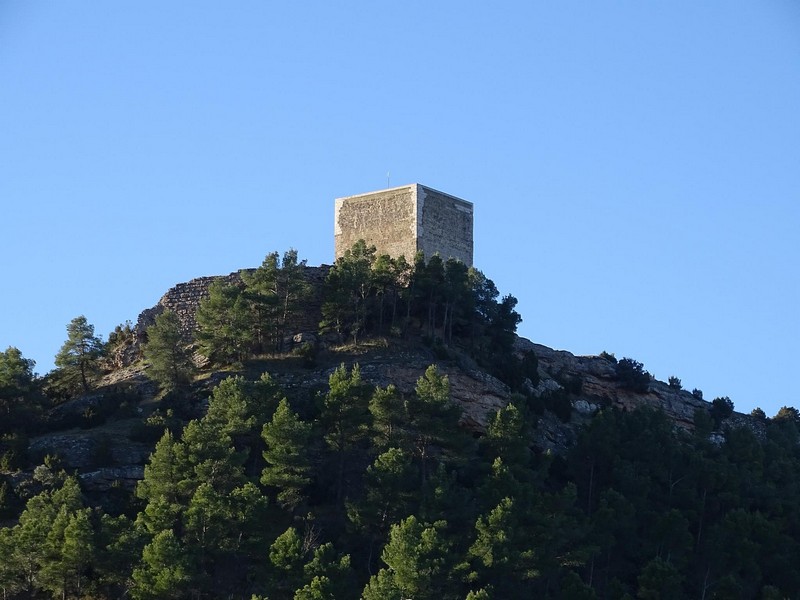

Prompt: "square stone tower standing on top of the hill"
[334,183,472,266]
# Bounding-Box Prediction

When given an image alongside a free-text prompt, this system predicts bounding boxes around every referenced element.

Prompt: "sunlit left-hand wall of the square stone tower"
[334,186,417,260]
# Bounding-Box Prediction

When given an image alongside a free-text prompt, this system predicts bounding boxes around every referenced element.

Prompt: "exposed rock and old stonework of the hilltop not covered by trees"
[21,258,752,488]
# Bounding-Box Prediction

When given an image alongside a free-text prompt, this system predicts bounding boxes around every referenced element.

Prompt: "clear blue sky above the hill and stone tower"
[0,0,800,415]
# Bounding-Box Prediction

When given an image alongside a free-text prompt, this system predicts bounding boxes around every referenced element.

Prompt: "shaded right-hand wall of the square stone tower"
[417,186,472,266]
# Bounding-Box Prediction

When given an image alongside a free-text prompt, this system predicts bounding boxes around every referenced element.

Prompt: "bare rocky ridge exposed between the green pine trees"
[23,265,763,491]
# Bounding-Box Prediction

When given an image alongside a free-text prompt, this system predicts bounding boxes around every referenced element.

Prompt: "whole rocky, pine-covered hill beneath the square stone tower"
[0,248,800,599]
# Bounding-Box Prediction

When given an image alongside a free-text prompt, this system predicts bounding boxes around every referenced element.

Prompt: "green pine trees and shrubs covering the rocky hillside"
[0,244,800,600]
